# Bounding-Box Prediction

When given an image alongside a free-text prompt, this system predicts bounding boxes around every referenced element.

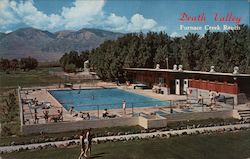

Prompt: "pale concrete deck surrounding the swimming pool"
[21,82,246,125]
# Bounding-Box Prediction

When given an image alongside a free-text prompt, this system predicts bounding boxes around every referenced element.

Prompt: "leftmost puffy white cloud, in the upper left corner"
[0,0,62,30]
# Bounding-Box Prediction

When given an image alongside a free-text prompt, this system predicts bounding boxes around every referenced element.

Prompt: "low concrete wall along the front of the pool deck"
[22,110,234,135]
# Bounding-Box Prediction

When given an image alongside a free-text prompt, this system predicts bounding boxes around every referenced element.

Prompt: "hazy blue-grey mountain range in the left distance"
[0,28,123,61]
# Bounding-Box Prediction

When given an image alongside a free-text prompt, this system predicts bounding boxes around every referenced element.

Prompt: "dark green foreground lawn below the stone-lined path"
[2,130,250,159]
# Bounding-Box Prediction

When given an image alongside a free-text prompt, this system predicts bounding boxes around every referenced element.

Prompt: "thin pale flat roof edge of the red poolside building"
[125,68,250,77]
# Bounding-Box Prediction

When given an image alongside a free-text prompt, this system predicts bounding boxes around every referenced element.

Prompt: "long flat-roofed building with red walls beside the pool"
[125,67,250,104]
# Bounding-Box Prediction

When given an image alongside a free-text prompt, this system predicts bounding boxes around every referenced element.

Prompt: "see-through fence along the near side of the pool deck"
[20,96,234,125]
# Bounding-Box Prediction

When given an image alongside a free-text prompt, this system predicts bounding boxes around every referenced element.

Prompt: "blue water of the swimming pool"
[49,88,169,111]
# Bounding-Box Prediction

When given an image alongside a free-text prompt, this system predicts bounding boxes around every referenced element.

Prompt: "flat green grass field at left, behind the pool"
[0,68,63,88]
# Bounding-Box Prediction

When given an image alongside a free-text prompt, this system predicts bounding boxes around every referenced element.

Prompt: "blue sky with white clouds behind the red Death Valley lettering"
[0,0,250,36]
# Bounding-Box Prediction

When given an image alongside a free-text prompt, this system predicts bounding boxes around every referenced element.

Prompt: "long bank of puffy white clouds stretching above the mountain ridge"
[0,0,166,32]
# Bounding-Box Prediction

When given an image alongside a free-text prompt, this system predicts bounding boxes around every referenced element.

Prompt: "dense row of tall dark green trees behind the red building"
[69,26,250,80]
